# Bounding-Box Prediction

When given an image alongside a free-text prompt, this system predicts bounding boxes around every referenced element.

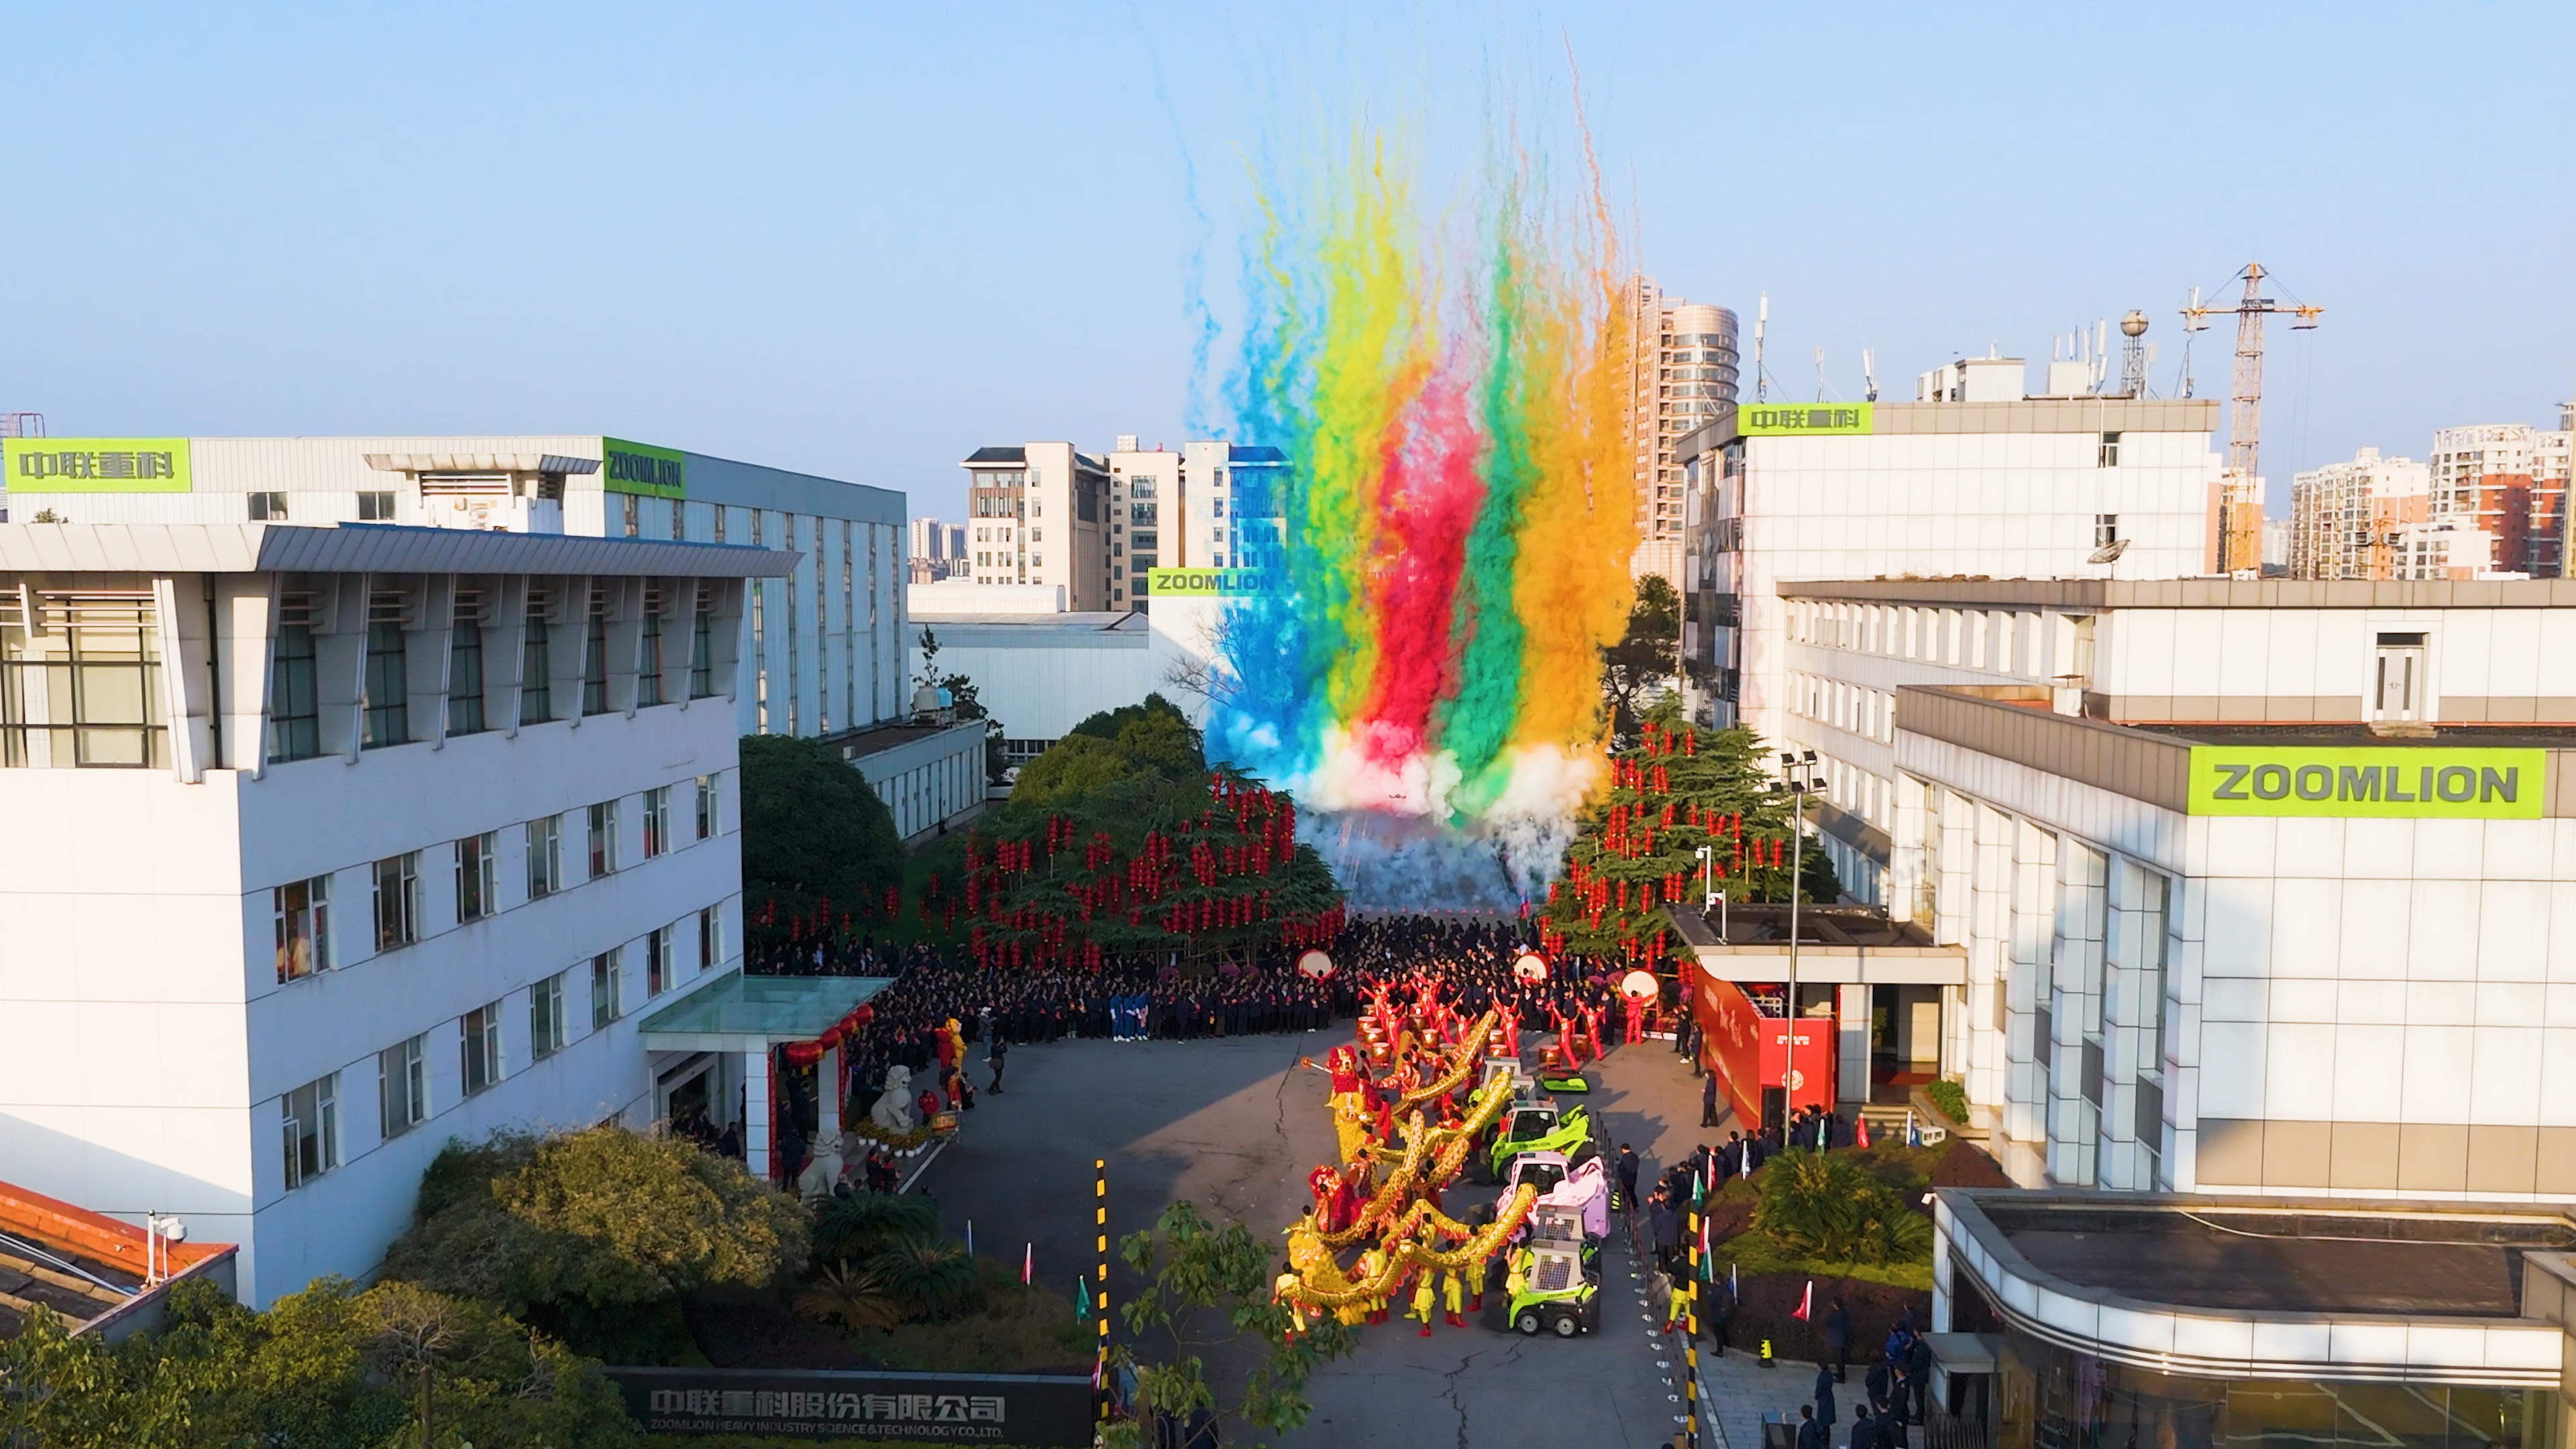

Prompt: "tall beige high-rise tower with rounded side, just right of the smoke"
[1628,276,1739,590]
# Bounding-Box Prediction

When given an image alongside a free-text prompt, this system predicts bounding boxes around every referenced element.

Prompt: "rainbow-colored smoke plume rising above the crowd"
[1208,137,1635,890]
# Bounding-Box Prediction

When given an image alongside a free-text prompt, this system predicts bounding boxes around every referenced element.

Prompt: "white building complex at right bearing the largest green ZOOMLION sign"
[1680,572,2576,1201]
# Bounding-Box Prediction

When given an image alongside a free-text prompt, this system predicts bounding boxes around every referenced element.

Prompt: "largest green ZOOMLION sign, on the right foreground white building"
[2190,745,2548,820]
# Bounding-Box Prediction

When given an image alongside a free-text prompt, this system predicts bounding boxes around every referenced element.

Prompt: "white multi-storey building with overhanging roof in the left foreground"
[0,515,793,1305]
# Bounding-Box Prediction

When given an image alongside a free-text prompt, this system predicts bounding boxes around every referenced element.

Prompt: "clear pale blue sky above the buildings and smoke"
[0,0,2576,516]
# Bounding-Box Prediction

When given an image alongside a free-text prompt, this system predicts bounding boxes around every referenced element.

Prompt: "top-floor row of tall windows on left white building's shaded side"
[268,596,716,763]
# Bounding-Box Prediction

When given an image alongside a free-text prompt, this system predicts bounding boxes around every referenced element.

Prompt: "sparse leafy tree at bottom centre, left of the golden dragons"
[1108,1199,1360,1449]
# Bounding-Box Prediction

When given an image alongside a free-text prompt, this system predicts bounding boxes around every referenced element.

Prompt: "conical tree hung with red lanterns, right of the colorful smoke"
[1538,699,1842,964]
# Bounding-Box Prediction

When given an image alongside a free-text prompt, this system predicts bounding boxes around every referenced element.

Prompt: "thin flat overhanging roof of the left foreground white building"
[0,523,804,578]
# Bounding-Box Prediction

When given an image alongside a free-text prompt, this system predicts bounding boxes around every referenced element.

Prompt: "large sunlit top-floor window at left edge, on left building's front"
[0,588,168,768]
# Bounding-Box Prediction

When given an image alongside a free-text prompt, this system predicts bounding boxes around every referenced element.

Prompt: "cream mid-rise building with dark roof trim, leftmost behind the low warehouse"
[958,433,1110,611]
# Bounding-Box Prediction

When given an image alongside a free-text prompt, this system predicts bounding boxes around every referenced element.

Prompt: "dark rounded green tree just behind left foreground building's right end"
[742,735,904,918]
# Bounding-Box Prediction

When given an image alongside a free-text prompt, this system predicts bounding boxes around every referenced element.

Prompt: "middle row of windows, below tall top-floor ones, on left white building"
[270,776,724,985]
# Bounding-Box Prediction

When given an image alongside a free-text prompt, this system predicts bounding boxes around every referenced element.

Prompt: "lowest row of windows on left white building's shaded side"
[278,905,724,1191]
